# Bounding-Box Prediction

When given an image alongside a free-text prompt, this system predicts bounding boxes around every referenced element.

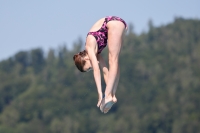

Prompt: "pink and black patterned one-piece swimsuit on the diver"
[87,16,127,54]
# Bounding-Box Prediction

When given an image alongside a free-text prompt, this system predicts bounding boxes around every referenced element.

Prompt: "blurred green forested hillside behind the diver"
[0,18,200,133]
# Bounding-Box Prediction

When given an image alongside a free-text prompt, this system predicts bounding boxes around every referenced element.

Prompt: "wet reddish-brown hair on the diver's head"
[73,50,87,72]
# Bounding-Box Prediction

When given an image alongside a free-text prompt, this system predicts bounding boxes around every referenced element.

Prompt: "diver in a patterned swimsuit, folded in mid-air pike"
[73,16,127,113]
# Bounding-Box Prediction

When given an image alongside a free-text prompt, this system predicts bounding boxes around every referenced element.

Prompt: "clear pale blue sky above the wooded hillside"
[0,0,200,61]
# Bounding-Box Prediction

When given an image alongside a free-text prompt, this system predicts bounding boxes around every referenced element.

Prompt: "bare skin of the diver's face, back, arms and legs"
[83,18,125,113]
